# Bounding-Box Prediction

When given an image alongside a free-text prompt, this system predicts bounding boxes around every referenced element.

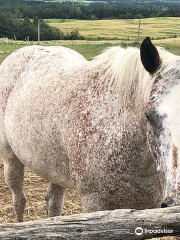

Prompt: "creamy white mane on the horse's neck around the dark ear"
[93,47,176,107]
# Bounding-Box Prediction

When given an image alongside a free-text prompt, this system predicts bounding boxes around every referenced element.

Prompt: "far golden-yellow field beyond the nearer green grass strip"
[46,17,180,41]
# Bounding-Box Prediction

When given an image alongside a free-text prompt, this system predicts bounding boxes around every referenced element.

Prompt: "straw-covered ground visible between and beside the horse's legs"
[0,162,82,223]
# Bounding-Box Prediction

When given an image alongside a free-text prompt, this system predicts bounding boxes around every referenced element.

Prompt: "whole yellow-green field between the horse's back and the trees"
[0,18,180,62]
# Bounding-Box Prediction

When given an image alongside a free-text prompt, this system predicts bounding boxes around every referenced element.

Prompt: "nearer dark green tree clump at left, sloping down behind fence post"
[0,8,84,41]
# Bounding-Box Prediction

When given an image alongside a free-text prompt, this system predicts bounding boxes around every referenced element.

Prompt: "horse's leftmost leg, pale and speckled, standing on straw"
[2,147,26,222]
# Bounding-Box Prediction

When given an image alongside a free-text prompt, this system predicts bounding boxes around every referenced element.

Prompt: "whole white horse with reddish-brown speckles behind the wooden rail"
[0,37,180,222]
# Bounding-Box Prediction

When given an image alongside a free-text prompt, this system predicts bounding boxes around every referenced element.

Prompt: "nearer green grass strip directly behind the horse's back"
[0,38,180,63]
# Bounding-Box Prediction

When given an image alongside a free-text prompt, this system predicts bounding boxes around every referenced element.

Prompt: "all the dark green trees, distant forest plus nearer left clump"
[0,0,180,41]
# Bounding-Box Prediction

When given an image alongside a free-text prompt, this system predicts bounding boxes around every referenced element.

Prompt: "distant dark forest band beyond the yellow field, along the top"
[0,0,180,19]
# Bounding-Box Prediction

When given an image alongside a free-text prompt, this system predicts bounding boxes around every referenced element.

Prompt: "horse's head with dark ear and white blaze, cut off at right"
[141,38,180,207]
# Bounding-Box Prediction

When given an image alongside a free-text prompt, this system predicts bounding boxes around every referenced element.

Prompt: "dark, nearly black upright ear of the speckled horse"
[140,37,161,74]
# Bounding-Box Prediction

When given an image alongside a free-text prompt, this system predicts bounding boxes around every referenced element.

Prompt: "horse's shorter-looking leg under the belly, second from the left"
[45,183,66,217]
